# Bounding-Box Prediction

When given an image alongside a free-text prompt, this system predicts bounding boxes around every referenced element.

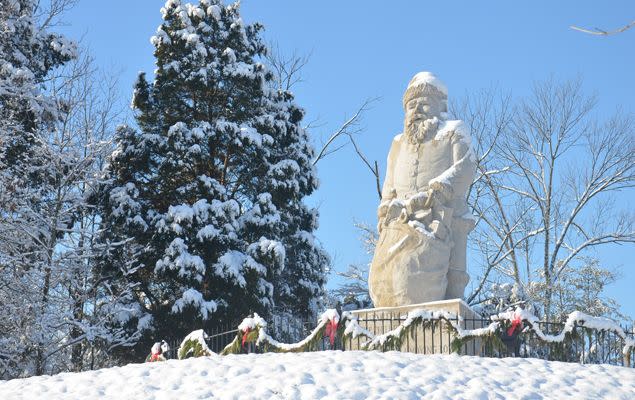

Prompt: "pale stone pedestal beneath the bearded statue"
[344,299,488,355]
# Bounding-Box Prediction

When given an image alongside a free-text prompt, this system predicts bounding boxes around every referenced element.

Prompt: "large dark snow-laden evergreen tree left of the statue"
[100,0,328,351]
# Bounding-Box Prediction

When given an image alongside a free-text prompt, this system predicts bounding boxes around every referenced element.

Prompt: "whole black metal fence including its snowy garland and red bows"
[171,310,635,368]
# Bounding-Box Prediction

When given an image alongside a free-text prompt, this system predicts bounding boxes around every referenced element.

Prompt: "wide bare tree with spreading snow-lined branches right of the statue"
[453,81,635,317]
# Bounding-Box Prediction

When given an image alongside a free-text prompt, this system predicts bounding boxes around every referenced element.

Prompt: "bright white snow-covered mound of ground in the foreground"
[0,351,635,400]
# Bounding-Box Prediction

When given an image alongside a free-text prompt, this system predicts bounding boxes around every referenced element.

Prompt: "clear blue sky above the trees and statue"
[57,0,635,317]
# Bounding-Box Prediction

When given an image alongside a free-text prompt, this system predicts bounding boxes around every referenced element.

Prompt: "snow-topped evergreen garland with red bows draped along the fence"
[179,309,635,365]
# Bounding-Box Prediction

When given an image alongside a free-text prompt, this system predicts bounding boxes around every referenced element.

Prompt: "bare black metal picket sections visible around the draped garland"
[170,316,635,368]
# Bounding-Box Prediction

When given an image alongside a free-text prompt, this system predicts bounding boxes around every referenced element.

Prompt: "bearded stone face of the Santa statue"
[404,95,447,144]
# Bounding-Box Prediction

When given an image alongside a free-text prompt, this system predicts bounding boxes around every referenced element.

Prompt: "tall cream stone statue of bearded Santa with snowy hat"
[369,72,476,307]
